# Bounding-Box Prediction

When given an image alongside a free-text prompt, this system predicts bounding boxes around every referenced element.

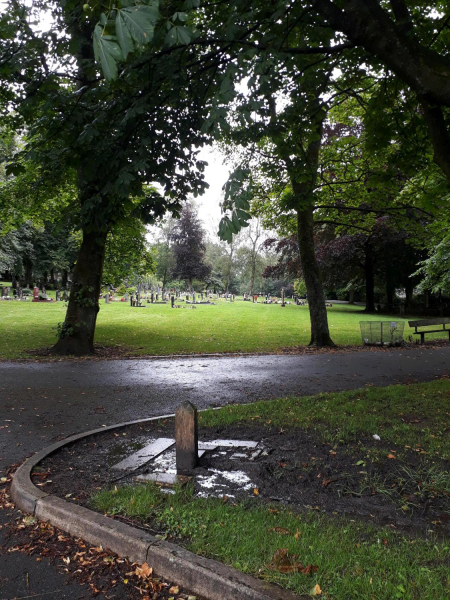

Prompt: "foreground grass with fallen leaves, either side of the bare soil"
[92,380,450,600]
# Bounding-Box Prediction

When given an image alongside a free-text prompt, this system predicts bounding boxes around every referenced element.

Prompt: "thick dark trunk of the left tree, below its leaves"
[53,231,107,356]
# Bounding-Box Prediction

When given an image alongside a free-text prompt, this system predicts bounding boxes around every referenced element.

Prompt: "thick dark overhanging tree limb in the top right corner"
[313,0,450,179]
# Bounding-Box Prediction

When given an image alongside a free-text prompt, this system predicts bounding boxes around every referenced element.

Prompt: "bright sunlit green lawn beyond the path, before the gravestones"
[0,292,448,358]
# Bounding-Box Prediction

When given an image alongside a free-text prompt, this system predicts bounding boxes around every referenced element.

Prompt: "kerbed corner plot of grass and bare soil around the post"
[29,379,450,600]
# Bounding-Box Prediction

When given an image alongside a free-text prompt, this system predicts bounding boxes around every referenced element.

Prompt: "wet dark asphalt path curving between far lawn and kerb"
[0,347,450,600]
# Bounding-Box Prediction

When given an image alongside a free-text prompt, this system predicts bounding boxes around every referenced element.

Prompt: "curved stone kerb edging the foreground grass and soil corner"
[11,414,299,600]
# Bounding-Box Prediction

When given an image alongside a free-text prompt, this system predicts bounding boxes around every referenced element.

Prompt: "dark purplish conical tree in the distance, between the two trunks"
[170,203,211,289]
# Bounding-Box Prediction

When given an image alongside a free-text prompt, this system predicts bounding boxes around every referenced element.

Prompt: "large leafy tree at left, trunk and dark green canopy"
[1,0,216,354]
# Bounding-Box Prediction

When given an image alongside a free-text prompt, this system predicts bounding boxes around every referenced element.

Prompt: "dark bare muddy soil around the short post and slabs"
[37,419,450,535]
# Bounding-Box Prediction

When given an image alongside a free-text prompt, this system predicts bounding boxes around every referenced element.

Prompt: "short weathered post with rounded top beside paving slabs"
[175,401,198,475]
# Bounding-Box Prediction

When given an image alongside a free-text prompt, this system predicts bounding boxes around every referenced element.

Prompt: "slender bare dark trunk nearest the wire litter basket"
[297,206,334,346]
